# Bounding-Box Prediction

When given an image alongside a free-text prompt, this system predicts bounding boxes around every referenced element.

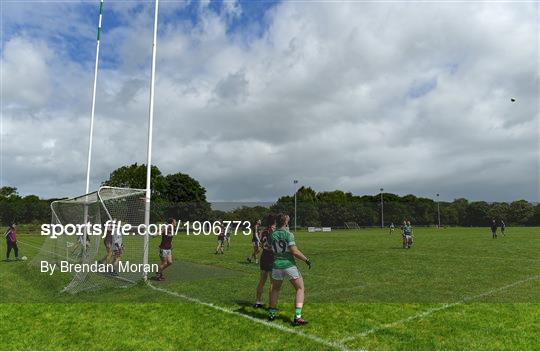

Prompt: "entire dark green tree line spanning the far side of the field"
[0,164,540,227]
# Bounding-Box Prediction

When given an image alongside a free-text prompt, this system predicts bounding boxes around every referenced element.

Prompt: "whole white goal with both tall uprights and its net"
[32,0,159,293]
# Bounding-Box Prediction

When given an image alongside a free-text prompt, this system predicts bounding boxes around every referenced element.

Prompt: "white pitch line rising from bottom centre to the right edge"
[340,275,540,343]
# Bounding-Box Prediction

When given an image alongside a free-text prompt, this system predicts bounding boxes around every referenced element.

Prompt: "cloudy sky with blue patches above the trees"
[0,0,540,201]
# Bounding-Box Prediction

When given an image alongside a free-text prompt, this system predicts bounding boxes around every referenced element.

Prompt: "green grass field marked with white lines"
[0,227,540,350]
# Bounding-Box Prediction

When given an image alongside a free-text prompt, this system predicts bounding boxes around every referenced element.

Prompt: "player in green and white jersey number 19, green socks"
[268,214,311,325]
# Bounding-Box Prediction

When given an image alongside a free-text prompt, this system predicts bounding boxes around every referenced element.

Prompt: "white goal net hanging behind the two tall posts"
[33,187,148,293]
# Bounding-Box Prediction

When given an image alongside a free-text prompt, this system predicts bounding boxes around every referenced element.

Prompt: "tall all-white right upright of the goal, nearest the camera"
[143,0,159,280]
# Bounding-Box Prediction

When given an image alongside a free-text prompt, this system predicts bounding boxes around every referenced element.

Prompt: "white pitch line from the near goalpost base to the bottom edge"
[147,282,349,351]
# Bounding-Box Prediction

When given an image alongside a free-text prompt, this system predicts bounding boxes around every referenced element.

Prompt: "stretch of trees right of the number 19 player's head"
[271,187,540,227]
